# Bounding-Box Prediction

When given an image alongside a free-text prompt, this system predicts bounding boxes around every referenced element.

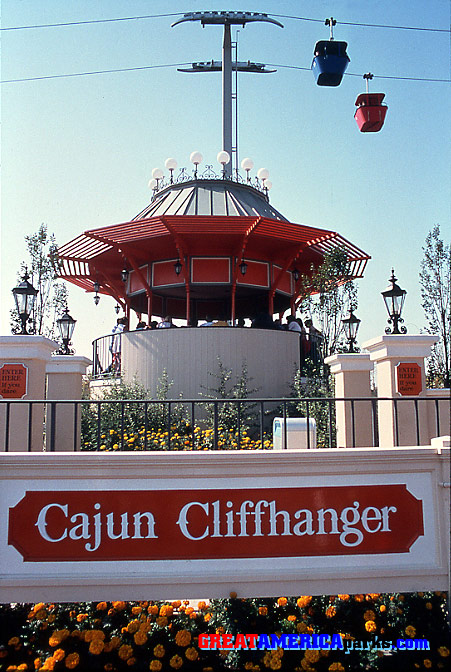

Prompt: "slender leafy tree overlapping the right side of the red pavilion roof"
[299,249,358,357]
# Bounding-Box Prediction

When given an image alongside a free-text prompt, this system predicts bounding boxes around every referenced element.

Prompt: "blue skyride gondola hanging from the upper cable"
[312,17,350,86]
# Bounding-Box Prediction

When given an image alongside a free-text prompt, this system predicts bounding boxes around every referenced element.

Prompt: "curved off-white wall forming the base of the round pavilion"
[122,327,299,399]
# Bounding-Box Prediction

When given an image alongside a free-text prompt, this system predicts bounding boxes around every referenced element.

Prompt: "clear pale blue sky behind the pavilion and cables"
[0,0,451,355]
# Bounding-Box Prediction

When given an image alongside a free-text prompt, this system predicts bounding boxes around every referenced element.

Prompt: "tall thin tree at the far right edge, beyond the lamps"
[420,225,451,388]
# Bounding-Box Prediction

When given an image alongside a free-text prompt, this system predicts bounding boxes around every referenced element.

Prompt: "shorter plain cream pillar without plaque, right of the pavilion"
[324,353,374,448]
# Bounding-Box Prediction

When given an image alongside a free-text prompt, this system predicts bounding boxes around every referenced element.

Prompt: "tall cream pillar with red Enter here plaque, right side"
[362,334,439,448]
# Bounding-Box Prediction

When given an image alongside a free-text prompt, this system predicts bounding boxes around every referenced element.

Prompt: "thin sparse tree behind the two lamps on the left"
[10,224,67,338]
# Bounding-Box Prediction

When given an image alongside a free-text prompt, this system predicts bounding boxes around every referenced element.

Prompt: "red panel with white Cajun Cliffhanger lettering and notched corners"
[8,484,423,562]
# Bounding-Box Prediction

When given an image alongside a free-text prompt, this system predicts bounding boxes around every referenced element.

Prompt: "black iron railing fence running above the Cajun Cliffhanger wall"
[0,397,450,452]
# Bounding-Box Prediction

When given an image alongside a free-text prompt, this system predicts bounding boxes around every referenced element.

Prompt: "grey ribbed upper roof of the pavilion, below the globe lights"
[133,180,288,222]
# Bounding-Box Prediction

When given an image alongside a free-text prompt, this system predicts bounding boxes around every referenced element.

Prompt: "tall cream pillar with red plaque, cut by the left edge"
[0,335,58,452]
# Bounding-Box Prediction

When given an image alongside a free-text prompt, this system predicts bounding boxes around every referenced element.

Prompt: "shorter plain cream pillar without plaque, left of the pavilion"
[46,355,92,451]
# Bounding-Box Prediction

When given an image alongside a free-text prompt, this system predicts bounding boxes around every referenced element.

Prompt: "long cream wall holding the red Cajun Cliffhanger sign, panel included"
[0,447,449,602]
